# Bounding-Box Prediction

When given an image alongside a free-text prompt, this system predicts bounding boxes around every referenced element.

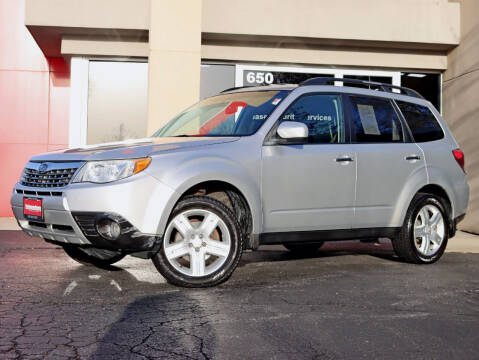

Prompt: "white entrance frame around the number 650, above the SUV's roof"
[235,65,401,87]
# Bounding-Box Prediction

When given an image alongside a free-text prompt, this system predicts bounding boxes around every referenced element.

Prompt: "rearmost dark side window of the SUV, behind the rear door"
[396,101,444,142]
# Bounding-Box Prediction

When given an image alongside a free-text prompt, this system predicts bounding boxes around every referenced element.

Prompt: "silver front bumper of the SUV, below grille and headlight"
[11,174,173,253]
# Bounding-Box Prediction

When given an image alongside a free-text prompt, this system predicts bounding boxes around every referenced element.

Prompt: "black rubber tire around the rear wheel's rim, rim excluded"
[407,195,449,264]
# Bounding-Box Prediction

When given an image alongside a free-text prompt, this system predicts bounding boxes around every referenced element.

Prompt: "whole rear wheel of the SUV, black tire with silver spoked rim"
[392,193,449,264]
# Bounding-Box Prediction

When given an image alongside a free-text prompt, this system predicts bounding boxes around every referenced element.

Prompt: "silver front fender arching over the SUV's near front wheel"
[149,154,262,235]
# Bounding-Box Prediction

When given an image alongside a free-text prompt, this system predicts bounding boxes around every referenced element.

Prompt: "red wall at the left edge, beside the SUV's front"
[0,0,70,216]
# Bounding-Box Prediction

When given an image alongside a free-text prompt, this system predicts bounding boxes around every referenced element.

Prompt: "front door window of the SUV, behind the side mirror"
[280,94,344,144]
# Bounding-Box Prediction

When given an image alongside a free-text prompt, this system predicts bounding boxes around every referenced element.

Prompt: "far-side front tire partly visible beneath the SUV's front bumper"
[63,245,125,268]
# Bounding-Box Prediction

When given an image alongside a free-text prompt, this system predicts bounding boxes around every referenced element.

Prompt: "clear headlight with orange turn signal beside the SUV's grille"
[73,158,151,183]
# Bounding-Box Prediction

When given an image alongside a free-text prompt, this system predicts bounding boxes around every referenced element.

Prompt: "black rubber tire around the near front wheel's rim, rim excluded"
[152,196,242,287]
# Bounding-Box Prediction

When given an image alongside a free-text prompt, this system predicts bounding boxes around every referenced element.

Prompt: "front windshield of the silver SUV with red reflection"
[153,90,289,137]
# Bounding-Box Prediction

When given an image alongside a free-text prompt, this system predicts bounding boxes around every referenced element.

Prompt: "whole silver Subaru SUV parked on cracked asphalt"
[11,78,469,287]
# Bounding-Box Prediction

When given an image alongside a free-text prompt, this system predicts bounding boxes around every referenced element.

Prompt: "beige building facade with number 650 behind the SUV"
[0,0,479,232]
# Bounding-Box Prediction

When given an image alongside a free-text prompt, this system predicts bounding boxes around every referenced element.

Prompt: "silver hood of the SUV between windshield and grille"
[30,137,239,161]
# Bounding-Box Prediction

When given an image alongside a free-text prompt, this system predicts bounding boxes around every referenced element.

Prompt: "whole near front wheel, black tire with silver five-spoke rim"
[152,196,244,287]
